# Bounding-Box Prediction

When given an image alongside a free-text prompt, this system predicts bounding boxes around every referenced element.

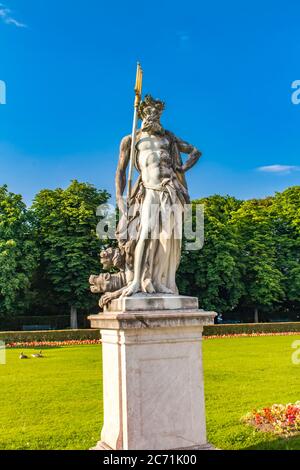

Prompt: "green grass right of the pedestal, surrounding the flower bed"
[204,336,300,450]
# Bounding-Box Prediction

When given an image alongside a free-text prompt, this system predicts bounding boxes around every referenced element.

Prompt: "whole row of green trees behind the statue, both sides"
[0,180,300,321]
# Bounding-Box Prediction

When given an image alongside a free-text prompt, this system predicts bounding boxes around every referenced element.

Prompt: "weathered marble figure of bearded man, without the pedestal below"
[90,67,201,307]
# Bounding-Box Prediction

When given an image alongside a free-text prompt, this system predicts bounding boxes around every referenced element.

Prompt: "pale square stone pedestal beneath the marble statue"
[89,294,216,450]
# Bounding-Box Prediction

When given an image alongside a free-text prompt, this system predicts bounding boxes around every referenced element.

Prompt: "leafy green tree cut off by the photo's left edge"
[0,186,38,317]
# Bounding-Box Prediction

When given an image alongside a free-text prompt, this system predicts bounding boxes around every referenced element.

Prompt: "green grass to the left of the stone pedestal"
[0,345,103,450]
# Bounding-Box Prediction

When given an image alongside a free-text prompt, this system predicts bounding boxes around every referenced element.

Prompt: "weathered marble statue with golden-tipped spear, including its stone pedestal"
[89,77,216,451]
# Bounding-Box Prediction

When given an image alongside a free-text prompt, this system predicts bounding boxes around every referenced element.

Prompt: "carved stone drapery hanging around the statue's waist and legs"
[117,131,189,294]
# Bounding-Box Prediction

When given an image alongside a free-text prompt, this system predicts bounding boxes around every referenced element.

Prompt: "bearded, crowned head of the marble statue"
[139,95,165,133]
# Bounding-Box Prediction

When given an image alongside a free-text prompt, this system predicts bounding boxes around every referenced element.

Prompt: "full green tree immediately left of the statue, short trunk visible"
[32,180,109,327]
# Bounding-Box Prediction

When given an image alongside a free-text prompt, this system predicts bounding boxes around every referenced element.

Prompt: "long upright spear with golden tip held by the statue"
[127,62,143,204]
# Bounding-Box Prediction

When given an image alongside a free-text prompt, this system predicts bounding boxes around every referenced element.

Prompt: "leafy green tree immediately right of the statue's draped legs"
[178,195,243,313]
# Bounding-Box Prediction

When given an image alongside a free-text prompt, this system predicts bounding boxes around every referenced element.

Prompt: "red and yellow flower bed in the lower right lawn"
[243,401,300,436]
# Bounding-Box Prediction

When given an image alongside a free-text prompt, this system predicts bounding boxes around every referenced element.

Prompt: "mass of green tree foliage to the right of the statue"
[178,186,300,319]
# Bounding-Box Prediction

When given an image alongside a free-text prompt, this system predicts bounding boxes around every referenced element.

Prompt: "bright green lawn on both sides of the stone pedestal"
[0,336,300,449]
